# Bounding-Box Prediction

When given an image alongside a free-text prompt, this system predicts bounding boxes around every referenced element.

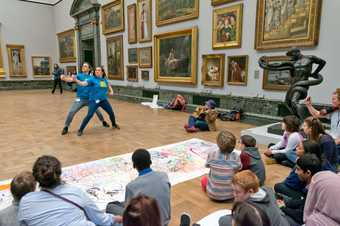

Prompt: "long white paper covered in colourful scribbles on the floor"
[0,139,217,210]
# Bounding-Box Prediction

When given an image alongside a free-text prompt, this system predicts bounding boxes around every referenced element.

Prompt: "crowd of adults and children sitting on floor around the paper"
[0,90,340,226]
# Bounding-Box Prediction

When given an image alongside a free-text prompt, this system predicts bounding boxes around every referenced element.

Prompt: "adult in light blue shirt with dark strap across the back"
[18,155,122,226]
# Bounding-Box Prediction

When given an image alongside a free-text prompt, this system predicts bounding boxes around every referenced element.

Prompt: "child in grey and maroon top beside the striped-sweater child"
[240,135,266,186]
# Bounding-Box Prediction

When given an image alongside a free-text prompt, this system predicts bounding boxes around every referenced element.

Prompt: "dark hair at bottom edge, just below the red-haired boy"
[231,202,271,226]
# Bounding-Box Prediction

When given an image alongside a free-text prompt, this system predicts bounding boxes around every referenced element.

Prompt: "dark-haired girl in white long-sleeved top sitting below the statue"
[264,115,303,167]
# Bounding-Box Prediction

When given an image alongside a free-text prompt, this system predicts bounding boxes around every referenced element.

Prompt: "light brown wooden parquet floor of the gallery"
[0,90,289,226]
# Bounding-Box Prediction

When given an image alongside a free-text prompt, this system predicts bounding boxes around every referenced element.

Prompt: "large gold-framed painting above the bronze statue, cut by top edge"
[255,0,322,50]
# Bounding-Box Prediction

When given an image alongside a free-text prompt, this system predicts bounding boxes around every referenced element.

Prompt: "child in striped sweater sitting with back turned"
[201,130,242,201]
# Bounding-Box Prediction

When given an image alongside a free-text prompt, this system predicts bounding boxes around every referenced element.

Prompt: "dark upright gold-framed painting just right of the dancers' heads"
[106,35,124,80]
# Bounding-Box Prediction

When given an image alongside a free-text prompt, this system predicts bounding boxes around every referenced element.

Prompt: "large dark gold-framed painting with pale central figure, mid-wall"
[154,27,198,85]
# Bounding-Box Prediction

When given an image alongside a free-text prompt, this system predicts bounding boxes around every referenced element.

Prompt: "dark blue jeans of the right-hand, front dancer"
[79,100,116,131]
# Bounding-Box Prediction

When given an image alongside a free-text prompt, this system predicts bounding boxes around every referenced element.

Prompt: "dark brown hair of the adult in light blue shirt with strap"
[33,155,61,188]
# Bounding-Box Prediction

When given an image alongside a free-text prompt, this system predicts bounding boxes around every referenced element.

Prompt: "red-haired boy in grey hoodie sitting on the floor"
[219,170,290,226]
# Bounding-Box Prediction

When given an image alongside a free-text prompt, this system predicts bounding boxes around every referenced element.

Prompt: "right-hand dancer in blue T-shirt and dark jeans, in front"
[73,67,120,136]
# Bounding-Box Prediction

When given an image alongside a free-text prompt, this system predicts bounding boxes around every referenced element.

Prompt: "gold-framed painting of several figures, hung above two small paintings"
[212,4,243,49]
